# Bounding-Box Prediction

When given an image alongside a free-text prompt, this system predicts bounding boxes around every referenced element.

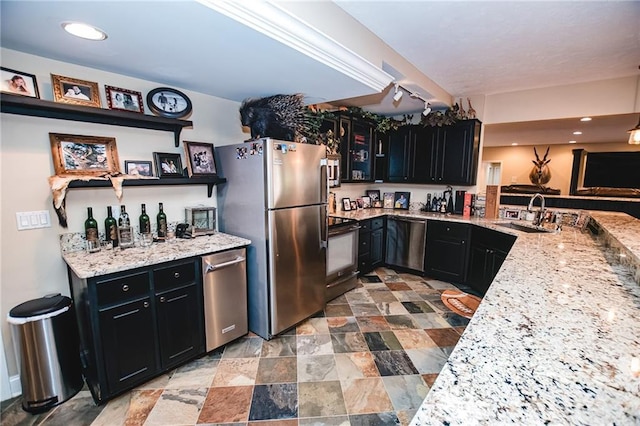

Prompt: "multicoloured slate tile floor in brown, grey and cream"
[0,268,480,426]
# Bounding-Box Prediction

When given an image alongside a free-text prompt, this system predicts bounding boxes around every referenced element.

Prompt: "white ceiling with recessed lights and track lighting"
[0,0,640,145]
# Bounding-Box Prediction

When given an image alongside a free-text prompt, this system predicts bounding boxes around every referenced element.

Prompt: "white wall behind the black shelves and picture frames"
[0,49,249,382]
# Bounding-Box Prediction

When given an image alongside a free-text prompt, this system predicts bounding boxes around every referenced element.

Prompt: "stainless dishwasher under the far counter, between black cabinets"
[385,216,427,273]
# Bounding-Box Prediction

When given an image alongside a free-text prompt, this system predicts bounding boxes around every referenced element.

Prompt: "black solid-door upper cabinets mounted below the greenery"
[385,120,481,185]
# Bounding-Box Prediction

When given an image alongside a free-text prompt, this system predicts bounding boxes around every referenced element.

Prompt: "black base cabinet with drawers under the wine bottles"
[69,258,205,403]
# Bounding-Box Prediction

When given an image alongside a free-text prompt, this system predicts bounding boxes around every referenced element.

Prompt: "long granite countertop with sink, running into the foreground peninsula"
[337,209,640,425]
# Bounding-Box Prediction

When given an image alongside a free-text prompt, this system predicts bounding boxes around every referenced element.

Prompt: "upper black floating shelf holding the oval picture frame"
[0,93,193,147]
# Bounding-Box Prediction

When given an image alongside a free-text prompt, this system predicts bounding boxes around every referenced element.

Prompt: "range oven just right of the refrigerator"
[325,216,360,302]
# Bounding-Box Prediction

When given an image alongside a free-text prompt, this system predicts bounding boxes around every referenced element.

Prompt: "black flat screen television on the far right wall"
[583,151,640,188]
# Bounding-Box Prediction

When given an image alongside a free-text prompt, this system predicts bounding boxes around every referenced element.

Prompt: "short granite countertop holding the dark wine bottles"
[62,232,251,279]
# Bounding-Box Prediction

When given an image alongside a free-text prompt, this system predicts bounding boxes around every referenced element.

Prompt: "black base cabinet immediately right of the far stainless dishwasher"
[425,220,471,283]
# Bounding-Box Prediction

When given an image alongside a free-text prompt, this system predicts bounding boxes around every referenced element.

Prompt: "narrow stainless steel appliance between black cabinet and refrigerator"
[202,248,249,352]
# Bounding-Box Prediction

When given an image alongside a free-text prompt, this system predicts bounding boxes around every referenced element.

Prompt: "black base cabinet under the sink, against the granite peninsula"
[467,226,516,294]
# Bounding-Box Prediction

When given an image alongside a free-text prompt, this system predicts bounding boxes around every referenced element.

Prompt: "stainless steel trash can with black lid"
[7,293,83,413]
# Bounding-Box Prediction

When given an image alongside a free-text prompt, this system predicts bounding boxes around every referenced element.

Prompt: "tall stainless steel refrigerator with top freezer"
[216,138,327,340]
